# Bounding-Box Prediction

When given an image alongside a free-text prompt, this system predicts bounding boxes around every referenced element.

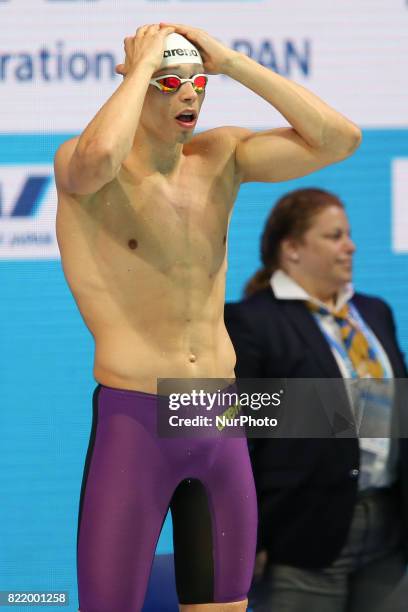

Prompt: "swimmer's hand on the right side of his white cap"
[160,23,237,74]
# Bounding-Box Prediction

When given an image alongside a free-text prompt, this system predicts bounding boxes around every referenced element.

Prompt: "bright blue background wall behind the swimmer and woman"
[0,130,408,610]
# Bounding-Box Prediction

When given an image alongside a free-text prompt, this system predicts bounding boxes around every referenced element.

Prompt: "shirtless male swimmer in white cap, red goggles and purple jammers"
[55,24,361,612]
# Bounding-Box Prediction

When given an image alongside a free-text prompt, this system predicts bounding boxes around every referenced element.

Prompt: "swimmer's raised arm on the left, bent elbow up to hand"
[55,25,174,194]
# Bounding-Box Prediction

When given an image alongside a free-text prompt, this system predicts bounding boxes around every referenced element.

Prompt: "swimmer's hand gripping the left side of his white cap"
[116,24,175,77]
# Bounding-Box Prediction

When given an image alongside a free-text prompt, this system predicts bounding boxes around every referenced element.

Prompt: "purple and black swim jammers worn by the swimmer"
[77,385,257,612]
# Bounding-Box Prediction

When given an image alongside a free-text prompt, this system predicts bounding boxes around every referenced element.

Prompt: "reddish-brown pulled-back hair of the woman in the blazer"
[244,188,344,296]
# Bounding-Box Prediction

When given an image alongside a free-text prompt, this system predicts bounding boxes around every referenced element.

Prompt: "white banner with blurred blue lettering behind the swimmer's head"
[0,0,408,133]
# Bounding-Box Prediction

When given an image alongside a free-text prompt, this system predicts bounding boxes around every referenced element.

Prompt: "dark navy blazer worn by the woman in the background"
[225,288,408,568]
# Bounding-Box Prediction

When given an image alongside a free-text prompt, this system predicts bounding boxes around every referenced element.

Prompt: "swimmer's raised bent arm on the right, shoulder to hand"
[166,24,361,182]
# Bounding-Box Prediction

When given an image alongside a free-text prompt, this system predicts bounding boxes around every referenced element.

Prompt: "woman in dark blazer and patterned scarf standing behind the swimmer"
[225,189,408,612]
